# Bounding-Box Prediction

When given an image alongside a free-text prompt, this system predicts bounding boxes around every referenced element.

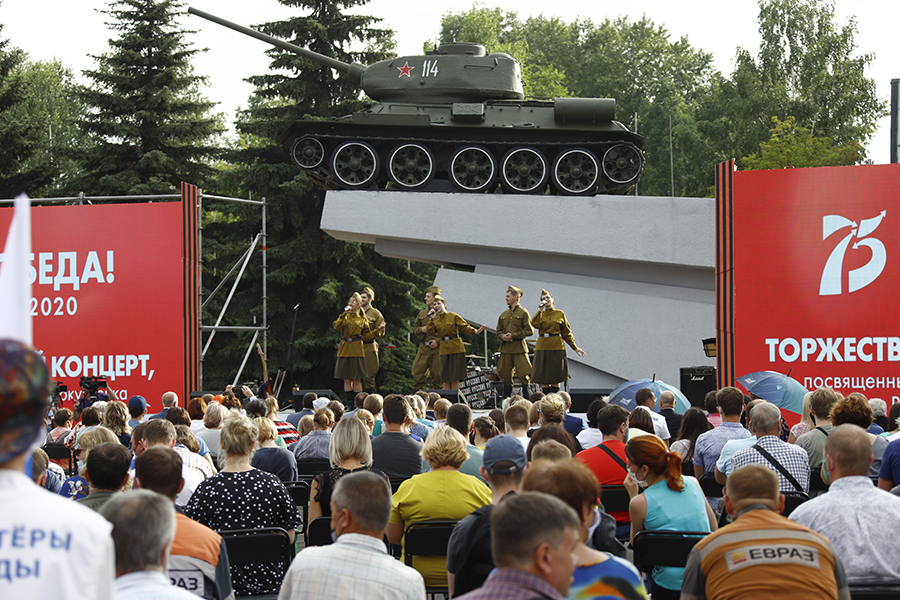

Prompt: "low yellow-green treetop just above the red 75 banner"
[743,117,865,170]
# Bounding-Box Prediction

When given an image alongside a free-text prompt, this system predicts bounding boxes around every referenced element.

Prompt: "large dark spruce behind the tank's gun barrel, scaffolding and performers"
[203,0,434,392]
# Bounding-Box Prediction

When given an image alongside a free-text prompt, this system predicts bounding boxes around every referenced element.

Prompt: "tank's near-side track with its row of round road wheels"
[290,132,644,196]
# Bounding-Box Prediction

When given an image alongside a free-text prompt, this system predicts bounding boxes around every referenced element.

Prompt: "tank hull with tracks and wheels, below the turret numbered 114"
[280,98,644,195]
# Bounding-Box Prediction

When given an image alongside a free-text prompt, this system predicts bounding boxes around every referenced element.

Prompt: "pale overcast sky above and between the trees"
[0,0,900,164]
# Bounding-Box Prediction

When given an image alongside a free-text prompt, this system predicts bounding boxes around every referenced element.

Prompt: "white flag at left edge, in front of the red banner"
[0,194,34,346]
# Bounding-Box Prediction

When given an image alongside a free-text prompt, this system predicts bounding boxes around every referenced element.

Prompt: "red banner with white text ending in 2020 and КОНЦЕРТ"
[0,202,185,412]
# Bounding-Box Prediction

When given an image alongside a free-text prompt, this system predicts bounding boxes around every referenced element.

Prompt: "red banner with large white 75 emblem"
[733,165,900,405]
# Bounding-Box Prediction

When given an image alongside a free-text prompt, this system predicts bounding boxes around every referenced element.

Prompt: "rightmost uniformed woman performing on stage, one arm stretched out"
[531,290,585,393]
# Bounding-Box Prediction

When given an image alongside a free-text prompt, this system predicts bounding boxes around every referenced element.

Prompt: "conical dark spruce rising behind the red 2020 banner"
[65,0,222,195]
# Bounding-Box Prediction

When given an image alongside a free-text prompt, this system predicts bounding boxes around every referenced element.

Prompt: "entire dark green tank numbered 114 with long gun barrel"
[188,8,644,195]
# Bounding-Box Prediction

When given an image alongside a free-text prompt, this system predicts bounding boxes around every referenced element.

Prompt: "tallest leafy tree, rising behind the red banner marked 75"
[699,0,886,167]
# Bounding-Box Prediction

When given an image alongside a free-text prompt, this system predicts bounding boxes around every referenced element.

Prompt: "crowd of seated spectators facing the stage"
[0,341,900,600]
